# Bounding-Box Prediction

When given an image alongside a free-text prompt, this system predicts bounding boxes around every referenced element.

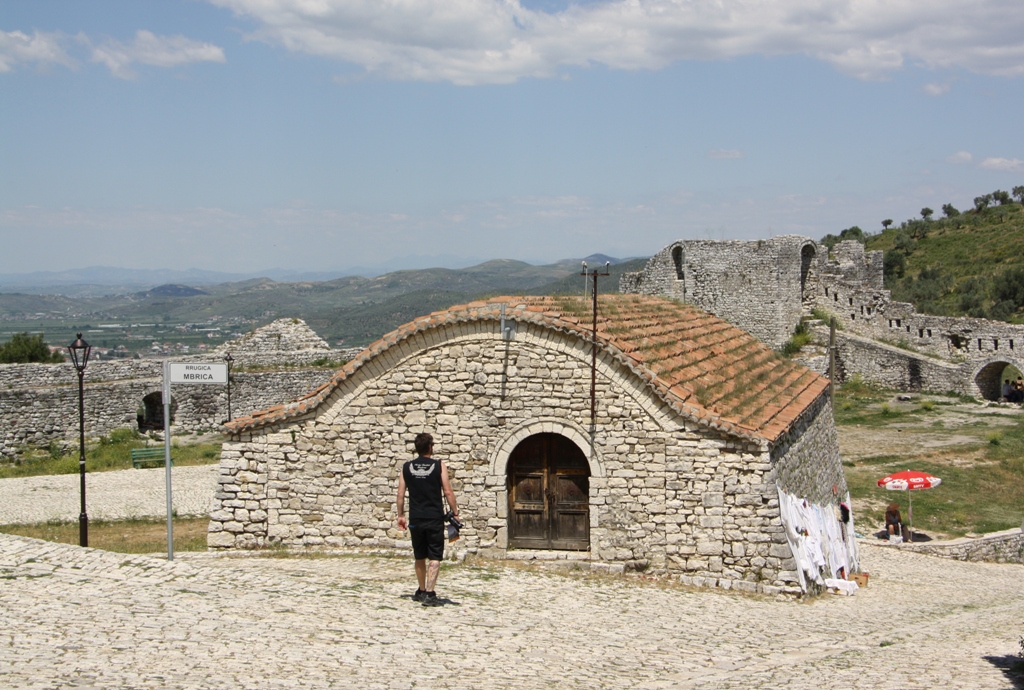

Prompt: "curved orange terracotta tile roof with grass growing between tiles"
[225,295,828,442]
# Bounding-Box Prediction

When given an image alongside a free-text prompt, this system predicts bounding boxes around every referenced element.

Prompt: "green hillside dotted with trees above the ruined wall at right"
[847,193,1024,324]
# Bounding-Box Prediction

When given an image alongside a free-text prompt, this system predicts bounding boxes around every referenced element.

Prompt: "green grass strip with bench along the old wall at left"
[0,429,221,479]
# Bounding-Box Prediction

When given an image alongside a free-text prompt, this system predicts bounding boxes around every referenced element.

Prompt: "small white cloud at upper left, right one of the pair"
[92,31,224,79]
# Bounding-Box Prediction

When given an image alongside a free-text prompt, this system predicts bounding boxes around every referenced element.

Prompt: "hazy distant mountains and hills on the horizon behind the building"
[0,254,646,346]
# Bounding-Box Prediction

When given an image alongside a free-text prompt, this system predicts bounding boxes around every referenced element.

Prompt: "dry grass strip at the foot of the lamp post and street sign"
[0,518,210,554]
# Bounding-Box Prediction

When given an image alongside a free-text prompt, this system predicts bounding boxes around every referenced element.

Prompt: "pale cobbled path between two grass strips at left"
[0,465,219,524]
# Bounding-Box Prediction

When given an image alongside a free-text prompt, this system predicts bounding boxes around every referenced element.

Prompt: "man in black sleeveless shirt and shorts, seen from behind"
[397,433,459,606]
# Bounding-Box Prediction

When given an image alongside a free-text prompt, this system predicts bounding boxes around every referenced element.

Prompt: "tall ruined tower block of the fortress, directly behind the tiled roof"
[618,235,820,348]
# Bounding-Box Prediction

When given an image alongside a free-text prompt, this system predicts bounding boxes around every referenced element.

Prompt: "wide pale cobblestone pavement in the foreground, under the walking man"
[0,534,1024,690]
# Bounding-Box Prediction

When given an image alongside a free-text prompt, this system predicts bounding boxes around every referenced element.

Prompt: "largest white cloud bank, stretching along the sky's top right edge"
[209,0,1024,84]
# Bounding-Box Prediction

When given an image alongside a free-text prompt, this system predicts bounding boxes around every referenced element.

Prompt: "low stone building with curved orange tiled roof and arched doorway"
[208,295,855,592]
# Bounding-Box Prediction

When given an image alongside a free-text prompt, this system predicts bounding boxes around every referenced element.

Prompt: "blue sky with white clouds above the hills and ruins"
[0,0,1024,273]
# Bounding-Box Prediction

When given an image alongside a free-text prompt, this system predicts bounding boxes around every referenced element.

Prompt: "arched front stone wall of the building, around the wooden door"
[208,321,838,592]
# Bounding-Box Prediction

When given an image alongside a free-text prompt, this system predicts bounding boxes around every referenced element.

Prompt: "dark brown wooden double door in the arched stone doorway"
[508,433,590,551]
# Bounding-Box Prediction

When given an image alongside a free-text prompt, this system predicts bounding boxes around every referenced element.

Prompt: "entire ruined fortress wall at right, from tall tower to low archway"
[620,235,1024,400]
